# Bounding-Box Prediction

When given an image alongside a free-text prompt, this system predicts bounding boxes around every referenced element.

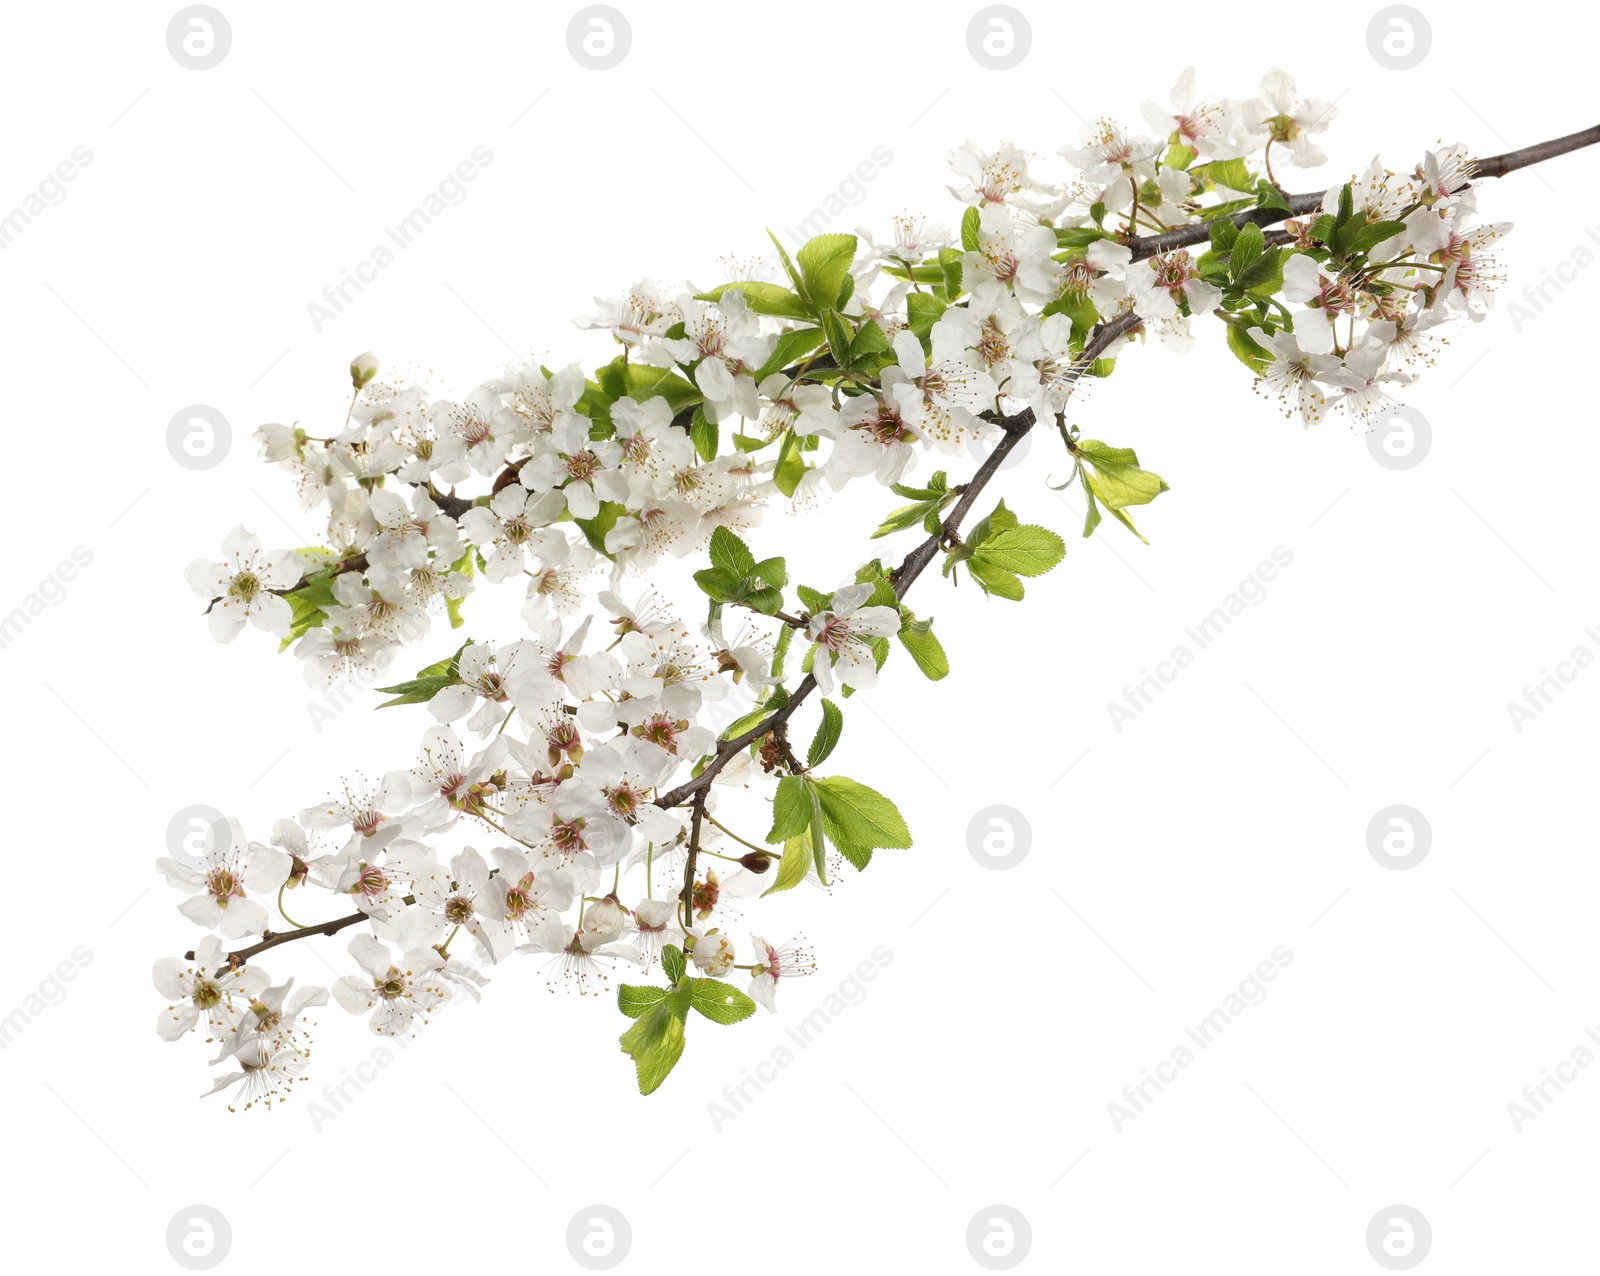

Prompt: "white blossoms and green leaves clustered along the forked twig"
[155,70,1506,1107]
